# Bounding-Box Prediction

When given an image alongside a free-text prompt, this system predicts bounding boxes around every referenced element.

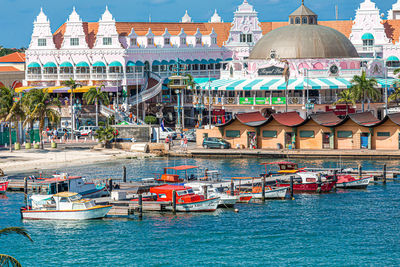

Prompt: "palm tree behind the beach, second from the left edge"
[26,89,60,149]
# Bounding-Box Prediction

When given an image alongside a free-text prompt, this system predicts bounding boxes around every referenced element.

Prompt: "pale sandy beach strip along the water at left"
[0,149,154,174]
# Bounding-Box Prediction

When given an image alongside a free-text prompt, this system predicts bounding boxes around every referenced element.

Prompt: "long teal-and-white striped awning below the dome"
[198,77,351,91]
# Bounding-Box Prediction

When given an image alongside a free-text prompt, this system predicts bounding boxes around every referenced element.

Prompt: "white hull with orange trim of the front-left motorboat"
[21,205,112,220]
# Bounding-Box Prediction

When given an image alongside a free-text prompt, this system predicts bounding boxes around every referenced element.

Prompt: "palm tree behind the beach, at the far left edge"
[0,87,24,152]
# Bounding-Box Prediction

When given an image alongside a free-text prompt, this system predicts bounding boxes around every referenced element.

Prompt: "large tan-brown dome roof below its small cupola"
[249,24,359,59]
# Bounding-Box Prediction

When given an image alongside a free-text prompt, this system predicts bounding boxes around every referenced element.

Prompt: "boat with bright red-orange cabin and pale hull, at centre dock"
[138,185,219,212]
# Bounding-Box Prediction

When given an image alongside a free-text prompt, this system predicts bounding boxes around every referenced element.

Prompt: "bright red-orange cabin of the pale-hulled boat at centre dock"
[150,185,204,204]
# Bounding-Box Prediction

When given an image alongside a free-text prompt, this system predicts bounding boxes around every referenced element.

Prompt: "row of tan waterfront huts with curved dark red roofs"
[197,112,400,150]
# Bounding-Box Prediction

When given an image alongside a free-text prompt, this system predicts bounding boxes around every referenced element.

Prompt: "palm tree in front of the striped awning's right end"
[350,71,381,112]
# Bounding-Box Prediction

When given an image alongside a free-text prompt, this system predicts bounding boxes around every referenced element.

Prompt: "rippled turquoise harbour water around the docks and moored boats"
[0,159,400,266]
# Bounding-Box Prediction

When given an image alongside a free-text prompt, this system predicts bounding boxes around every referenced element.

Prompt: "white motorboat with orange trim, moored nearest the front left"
[21,192,112,220]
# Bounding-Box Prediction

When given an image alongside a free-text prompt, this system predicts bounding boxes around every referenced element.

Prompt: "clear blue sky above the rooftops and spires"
[0,0,396,48]
